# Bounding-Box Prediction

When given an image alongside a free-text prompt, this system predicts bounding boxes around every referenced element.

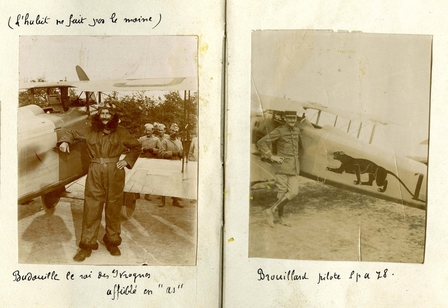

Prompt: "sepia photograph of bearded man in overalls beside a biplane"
[17,36,199,266]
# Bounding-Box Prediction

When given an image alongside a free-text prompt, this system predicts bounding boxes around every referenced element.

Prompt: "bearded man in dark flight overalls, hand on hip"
[58,103,141,262]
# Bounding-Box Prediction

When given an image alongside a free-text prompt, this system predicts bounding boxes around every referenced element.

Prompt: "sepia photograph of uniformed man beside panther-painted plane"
[248,30,432,263]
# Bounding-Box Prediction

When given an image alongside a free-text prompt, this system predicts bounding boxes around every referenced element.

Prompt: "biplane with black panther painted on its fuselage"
[251,93,427,209]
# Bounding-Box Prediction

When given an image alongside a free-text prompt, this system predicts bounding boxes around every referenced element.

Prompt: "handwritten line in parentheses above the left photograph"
[8,13,162,30]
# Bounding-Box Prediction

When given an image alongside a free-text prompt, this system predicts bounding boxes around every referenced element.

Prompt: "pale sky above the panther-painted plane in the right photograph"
[252,30,432,155]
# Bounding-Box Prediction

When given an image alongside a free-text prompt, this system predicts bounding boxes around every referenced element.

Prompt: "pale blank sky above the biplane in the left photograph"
[19,35,197,82]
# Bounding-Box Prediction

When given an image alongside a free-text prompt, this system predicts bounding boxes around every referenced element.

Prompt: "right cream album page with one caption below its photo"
[228,1,448,307]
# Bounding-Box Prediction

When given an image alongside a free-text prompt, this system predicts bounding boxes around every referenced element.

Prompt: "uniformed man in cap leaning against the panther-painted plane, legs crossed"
[257,111,300,228]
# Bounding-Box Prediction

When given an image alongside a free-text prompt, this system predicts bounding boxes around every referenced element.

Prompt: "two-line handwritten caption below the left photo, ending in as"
[12,269,186,300]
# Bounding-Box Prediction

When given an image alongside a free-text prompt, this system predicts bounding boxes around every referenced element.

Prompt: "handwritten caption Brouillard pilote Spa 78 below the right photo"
[257,268,394,284]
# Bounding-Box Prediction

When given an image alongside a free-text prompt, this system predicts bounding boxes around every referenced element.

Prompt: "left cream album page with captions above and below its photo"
[0,1,224,307]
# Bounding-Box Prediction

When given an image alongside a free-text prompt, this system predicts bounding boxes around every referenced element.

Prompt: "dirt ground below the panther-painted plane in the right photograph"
[249,177,426,263]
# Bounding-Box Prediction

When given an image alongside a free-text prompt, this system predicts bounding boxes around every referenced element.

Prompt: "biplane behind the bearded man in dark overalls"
[17,66,197,212]
